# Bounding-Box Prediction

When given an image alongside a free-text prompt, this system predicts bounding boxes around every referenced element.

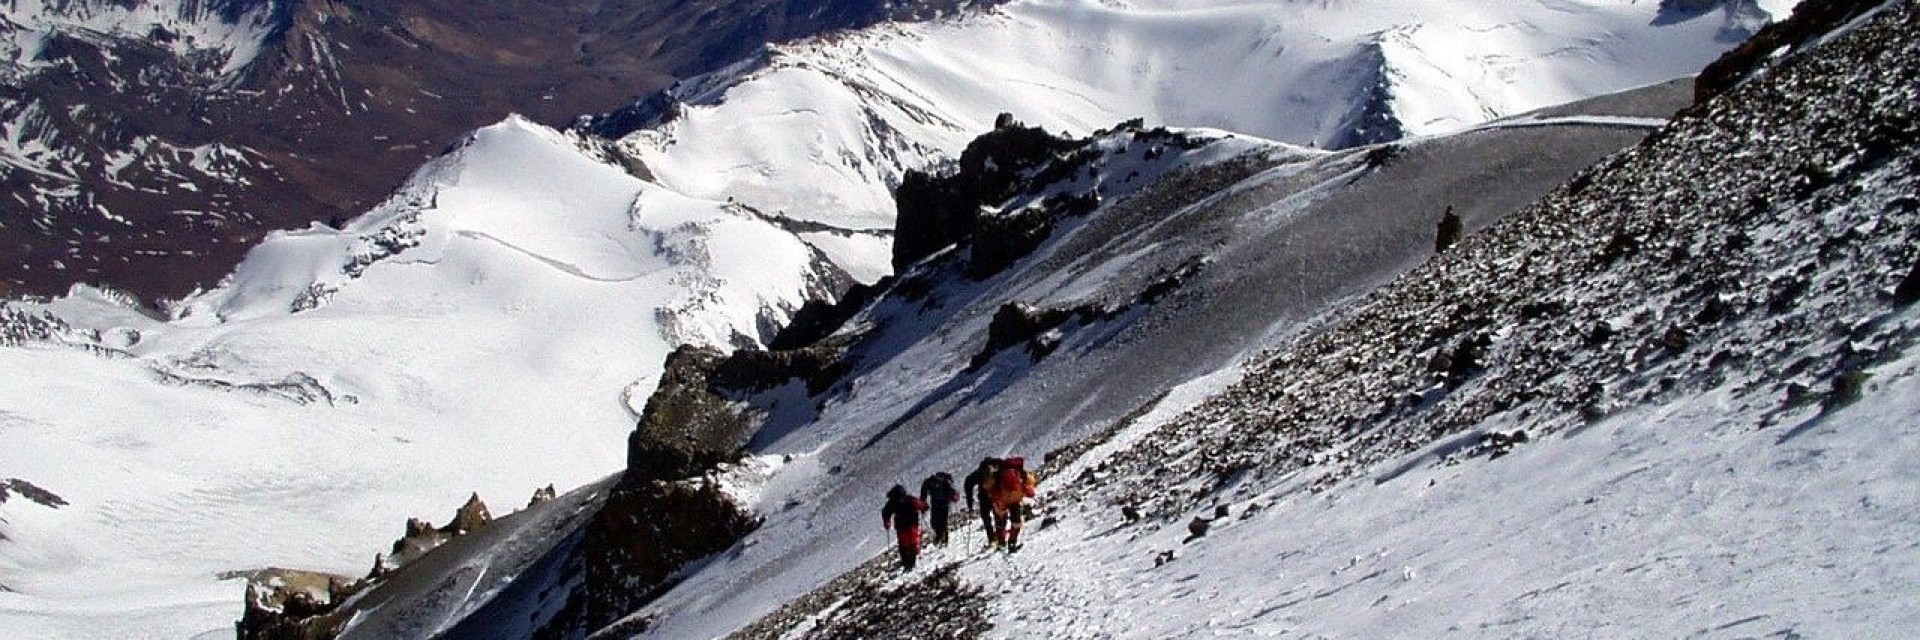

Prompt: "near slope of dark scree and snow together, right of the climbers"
[718,2,1920,638]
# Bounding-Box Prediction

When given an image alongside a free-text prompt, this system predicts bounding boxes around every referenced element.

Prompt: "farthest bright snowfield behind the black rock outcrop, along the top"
[622,0,1793,279]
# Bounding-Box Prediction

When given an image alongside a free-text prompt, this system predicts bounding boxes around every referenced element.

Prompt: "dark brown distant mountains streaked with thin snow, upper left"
[0,0,985,304]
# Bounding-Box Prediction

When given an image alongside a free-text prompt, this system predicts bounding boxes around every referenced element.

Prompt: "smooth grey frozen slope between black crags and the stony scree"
[618,88,1697,638]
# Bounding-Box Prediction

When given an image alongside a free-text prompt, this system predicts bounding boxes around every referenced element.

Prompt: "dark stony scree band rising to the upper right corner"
[1068,4,1920,530]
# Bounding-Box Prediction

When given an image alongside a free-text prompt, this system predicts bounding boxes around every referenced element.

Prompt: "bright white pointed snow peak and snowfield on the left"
[0,119,835,638]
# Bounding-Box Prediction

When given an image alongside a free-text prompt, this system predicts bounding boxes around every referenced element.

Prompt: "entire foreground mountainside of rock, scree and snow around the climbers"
[280,2,1920,638]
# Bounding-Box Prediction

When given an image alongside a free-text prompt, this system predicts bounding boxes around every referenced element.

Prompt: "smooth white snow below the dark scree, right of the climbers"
[967,338,1920,638]
